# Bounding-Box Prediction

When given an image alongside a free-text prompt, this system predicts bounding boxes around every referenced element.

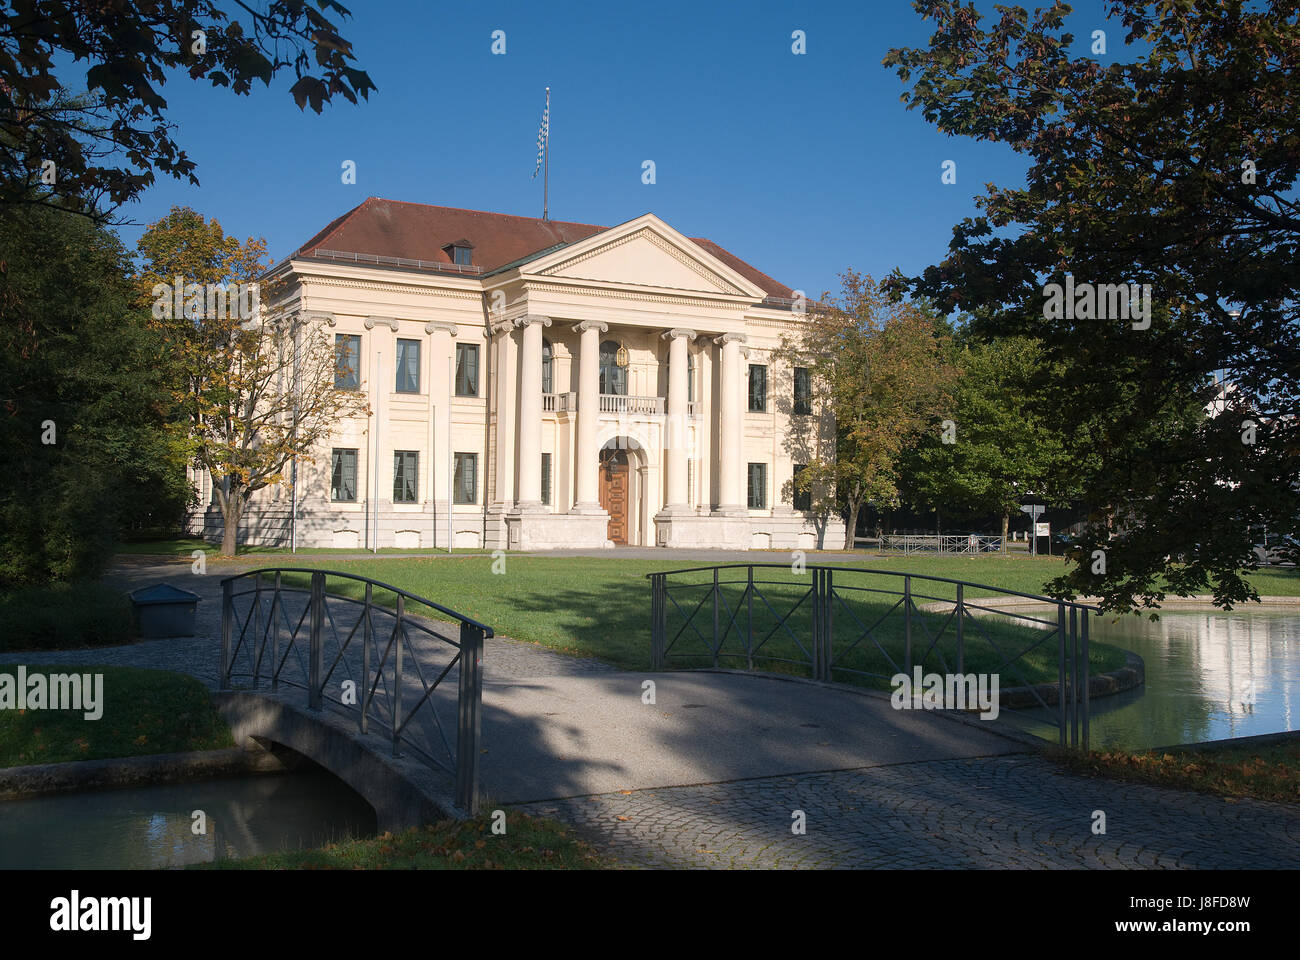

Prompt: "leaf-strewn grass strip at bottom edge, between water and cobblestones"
[202,813,615,870]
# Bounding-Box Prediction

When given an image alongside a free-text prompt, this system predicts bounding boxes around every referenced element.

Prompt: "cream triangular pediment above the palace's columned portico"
[528,215,763,298]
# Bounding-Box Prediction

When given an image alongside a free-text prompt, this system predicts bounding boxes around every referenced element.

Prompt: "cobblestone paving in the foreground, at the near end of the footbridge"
[512,754,1300,869]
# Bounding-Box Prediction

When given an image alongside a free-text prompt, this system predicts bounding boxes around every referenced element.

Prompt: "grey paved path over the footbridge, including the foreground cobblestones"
[10,562,1300,869]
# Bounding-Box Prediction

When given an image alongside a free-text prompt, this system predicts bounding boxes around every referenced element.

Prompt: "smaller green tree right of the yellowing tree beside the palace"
[901,338,1079,550]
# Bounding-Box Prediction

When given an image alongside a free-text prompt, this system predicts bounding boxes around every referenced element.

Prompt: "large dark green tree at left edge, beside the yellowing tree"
[0,201,191,587]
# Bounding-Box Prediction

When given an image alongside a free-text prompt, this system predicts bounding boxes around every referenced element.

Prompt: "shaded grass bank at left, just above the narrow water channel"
[0,663,235,766]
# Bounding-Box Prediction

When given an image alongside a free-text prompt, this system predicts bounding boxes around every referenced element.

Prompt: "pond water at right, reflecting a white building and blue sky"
[1022,607,1300,749]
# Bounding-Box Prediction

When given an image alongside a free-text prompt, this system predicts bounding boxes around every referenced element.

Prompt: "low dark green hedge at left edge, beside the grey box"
[0,574,133,653]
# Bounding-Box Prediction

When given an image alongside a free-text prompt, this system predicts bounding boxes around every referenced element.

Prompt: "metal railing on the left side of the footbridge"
[221,567,493,813]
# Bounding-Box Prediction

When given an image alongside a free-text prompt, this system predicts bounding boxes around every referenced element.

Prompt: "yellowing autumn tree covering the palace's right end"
[781,269,954,549]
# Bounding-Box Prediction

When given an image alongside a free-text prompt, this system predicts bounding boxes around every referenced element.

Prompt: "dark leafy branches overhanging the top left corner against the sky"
[0,0,376,221]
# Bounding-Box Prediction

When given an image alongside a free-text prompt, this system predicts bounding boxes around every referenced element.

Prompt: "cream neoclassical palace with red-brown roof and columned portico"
[194,198,844,550]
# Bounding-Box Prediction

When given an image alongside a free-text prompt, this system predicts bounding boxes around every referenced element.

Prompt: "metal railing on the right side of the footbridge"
[647,563,1100,751]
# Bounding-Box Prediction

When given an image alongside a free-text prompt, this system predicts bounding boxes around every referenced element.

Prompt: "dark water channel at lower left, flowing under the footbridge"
[0,770,376,869]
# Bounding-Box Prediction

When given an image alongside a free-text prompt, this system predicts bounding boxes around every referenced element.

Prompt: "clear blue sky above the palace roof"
[120,0,1121,295]
